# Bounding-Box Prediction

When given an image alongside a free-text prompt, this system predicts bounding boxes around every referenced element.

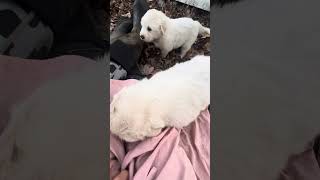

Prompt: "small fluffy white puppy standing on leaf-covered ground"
[140,9,210,58]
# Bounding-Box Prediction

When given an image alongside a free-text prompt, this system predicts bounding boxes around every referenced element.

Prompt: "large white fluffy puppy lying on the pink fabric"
[110,56,210,142]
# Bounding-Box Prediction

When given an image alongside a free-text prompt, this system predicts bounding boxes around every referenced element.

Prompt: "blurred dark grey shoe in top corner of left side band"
[0,1,53,58]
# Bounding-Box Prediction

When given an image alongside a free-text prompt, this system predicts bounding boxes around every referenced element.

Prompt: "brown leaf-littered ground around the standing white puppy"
[110,0,210,74]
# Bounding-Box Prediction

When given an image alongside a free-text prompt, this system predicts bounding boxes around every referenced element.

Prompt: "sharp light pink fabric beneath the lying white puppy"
[110,80,210,180]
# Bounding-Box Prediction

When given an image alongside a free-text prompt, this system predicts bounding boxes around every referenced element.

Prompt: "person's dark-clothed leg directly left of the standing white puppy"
[110,0,149,79]
